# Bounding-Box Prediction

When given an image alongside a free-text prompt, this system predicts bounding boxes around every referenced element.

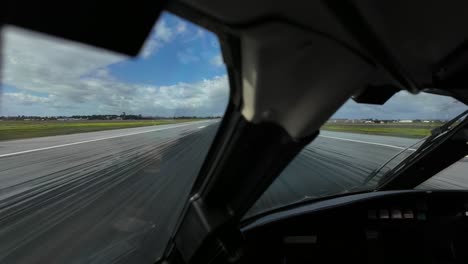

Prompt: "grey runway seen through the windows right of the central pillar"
[252,131,468,215]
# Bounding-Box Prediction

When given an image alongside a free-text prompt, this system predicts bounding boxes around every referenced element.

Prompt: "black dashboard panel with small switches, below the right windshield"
[242,191,468,263]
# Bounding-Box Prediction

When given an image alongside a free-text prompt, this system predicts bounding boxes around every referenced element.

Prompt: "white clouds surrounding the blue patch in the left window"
[0,26,228,116]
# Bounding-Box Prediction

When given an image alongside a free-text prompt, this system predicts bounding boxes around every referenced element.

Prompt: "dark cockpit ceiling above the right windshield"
[175,0,468,96]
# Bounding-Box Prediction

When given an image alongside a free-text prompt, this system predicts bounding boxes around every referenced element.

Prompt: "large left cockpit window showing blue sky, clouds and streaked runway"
[0,13,228,263]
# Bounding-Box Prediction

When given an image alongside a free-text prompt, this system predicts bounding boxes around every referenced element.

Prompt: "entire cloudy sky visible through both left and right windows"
[0,13,466,119]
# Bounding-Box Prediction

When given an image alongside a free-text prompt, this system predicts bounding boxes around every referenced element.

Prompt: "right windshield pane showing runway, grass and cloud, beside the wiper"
[245,92,468,217]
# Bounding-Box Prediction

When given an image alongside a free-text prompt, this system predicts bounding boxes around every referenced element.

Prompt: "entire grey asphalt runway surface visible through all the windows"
[0,121,468,263]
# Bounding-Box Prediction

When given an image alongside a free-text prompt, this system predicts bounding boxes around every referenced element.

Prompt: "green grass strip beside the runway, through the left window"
[0,119,198,141]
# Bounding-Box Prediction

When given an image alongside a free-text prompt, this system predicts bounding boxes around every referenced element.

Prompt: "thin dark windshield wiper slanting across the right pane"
[361,110,468,186]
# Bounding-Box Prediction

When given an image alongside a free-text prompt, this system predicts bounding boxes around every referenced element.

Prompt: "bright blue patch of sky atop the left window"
[109,13,226,85]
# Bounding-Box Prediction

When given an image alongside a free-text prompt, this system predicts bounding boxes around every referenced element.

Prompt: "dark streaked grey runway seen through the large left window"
[0,122,216,263]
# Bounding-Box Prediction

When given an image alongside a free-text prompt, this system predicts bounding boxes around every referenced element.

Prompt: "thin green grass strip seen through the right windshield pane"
[322,123,442,138]
